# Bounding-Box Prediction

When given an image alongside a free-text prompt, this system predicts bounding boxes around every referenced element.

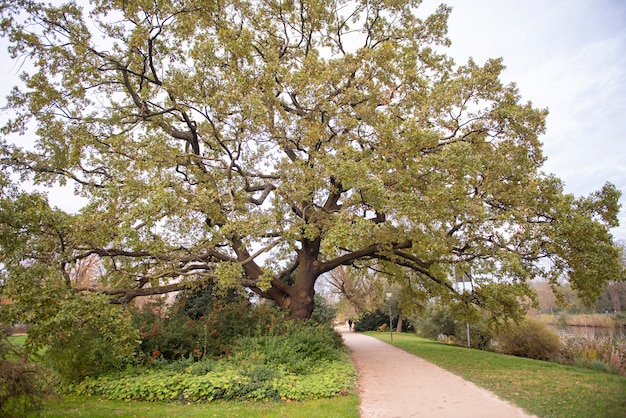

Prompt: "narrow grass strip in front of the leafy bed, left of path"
[41,393,359,418]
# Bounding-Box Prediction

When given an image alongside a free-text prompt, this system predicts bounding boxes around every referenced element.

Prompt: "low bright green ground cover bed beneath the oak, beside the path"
[66,322,356,402]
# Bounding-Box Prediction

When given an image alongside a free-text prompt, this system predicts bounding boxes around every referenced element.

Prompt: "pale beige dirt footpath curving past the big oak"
[339,328,532,418]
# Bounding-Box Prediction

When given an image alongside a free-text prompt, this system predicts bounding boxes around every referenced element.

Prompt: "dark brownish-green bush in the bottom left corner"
[0,334,51,417]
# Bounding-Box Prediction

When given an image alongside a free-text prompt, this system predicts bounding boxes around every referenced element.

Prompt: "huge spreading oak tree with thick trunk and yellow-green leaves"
[0,0,621,326]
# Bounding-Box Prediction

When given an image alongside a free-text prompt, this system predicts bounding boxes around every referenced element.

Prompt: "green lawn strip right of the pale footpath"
[367,332,626,418]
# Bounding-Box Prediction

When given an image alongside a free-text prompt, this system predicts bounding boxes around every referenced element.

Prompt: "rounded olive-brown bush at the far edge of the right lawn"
[496,318,561,360]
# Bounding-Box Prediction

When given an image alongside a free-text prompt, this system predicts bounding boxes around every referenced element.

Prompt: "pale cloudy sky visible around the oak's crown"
[0,0,626,240]
